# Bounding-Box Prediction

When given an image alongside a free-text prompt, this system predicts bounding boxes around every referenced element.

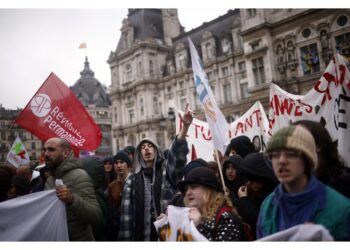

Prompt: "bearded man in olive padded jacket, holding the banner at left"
[45,138,103,241]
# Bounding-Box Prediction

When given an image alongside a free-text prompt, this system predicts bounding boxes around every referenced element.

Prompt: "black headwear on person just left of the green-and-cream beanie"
[240,153,278,183]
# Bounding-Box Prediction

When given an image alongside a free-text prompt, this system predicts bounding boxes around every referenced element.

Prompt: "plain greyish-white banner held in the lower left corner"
[0,190,69,241]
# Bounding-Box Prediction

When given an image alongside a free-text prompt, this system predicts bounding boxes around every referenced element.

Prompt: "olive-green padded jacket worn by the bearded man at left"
[45,153,104,241]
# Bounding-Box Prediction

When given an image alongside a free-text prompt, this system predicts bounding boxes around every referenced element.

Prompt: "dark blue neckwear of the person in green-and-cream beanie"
[273,176,326,231]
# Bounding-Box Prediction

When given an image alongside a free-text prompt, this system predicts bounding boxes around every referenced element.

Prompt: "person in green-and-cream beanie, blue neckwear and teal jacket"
[257,126,350,240]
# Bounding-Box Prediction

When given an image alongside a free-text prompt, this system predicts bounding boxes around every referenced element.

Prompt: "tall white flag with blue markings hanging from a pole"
[188,38,230,155]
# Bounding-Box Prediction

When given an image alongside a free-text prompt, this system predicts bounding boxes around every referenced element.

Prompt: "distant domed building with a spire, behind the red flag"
[70,57,112,156]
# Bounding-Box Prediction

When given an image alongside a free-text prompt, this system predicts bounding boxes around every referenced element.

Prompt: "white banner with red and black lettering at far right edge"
[269,55,350,166]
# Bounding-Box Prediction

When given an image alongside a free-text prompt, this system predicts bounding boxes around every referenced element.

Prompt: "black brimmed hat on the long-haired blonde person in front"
[177,167,222,194]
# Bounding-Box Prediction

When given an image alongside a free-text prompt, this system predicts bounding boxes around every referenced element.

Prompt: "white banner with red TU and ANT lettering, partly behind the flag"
[176,101,269,161]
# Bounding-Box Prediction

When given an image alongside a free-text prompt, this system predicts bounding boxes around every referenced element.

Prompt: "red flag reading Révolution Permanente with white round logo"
[15,73,102,151]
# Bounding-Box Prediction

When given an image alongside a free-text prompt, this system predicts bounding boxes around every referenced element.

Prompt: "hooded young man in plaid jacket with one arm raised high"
[119,104,193,241]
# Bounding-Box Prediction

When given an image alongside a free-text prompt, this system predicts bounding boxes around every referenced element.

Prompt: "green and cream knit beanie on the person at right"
[266,125,317,169]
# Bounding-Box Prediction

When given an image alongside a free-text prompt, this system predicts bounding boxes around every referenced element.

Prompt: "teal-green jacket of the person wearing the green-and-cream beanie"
[257,186,350,240]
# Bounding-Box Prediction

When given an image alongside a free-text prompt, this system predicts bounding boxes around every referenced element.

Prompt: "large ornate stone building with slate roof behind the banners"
[108,9,350,152]
